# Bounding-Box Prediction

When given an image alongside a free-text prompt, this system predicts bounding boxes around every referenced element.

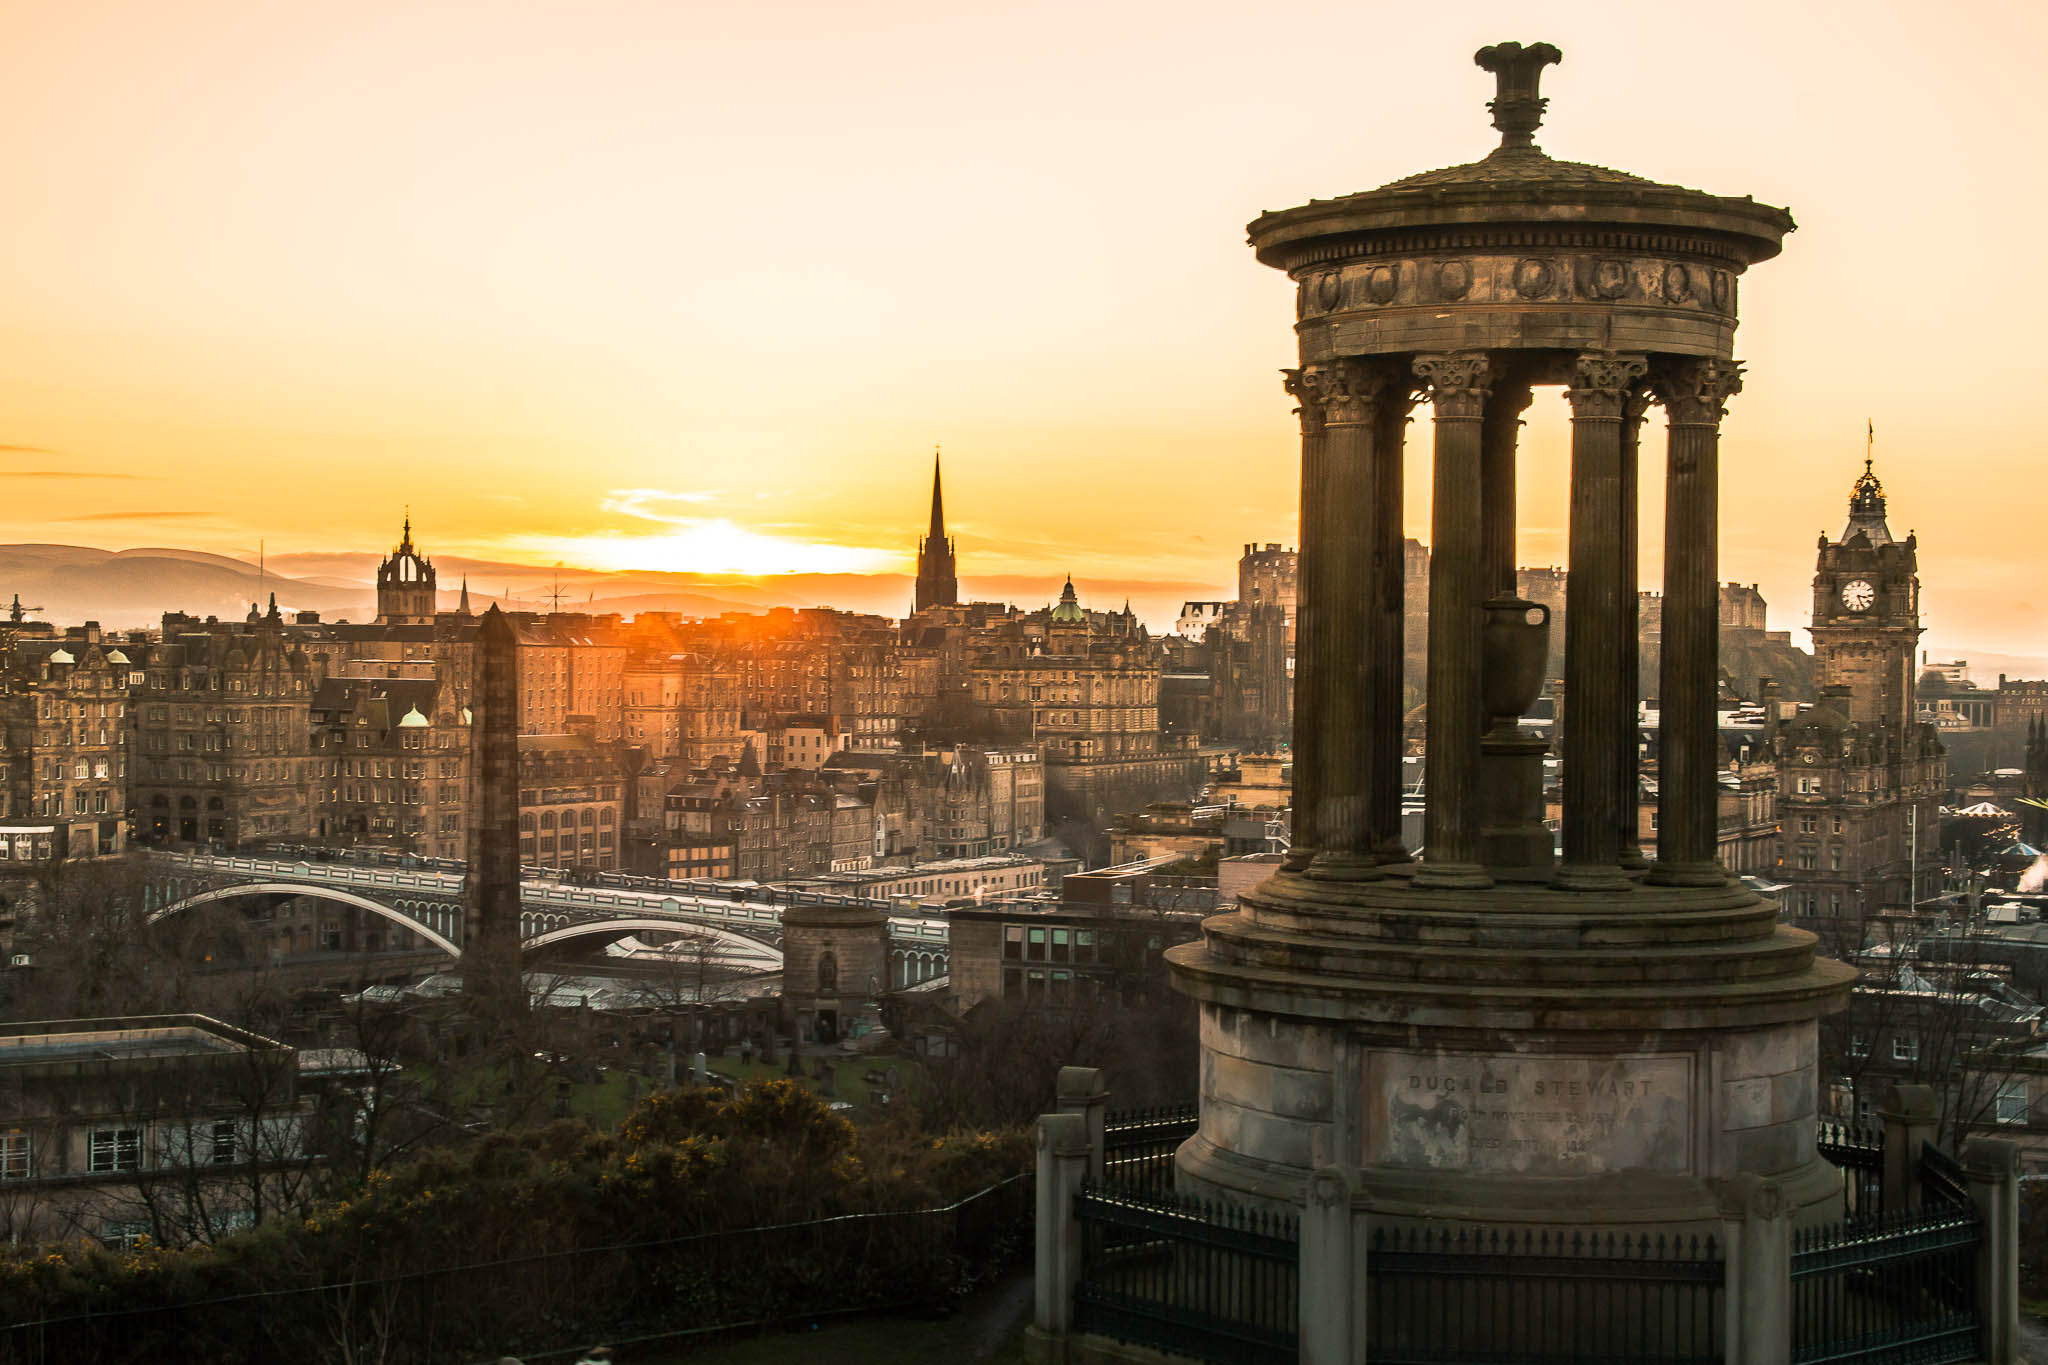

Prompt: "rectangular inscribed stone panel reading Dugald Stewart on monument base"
[1362,1052,1692,1175]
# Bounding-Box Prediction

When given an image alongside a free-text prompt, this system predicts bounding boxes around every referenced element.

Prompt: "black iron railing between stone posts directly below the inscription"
[1366,1228,1726,1365]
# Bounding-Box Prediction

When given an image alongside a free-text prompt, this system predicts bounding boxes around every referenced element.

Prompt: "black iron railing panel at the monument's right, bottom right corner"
[1792,1203,1985,1365]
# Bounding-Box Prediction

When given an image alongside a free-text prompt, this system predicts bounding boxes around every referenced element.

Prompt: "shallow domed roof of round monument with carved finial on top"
[1249,43,1792,268]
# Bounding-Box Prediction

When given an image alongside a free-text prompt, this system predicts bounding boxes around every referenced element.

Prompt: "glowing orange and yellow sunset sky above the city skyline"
[0,0,2048,655]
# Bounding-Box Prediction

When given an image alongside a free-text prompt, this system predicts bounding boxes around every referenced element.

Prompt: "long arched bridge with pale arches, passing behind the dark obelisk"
[147,853,948,988]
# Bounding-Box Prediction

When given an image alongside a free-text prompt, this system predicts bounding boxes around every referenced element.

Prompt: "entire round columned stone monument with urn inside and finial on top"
[1167,43,1853,1232]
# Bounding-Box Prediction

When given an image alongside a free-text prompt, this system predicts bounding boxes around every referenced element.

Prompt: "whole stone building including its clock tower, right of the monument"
[1767,460,1948,933]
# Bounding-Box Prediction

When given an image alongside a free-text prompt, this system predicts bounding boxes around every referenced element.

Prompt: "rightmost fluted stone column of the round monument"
[1653,360,1743,886]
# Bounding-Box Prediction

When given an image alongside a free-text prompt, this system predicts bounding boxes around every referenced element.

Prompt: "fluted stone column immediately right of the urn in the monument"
[1556,352,1649,890]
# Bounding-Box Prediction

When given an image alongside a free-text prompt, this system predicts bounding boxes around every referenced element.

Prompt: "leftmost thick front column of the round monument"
[1294,358,1389,878]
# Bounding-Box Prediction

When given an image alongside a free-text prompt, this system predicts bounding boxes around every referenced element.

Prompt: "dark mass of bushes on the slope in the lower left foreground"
[0,1081,1032,1365]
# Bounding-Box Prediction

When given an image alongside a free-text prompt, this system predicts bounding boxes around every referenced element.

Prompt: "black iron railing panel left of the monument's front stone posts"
[1073,1185,1300,1365]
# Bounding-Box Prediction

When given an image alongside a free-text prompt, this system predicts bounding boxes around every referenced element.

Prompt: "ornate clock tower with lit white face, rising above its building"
[1810,458,1921,735]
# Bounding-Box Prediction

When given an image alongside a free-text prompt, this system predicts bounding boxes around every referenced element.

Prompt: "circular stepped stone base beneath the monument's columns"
[1167,874,1855,1230]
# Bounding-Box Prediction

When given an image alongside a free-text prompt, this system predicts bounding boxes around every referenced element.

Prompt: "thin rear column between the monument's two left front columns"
[1366,392,1415,864]
